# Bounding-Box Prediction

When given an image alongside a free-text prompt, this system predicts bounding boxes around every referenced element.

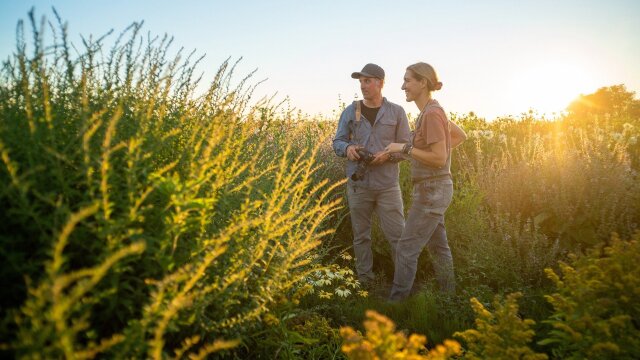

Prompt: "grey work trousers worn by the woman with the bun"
[389,179,456,301]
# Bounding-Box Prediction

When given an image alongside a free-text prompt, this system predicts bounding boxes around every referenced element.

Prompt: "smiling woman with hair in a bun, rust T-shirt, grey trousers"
[385,62,466,301]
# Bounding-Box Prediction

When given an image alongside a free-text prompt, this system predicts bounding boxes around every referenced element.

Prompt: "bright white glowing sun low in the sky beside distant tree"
[505,61,593,115]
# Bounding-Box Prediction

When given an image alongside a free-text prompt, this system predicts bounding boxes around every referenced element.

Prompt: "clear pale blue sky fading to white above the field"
[0,0,640,119]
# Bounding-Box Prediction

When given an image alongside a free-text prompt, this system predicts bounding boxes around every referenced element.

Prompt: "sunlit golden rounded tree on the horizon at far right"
[567,84,640,121]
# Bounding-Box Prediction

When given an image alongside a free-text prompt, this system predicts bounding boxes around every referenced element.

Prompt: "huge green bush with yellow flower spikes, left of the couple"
[0,9,340,359]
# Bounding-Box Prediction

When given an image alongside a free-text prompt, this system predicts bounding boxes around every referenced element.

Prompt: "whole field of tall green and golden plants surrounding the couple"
[0,13,640,359]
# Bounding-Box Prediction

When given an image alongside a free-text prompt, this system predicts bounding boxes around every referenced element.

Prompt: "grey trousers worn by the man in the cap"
[347,181,404,282]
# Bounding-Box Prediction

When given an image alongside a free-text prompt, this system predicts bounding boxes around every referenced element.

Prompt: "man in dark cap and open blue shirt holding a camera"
[333,64,411,285]
